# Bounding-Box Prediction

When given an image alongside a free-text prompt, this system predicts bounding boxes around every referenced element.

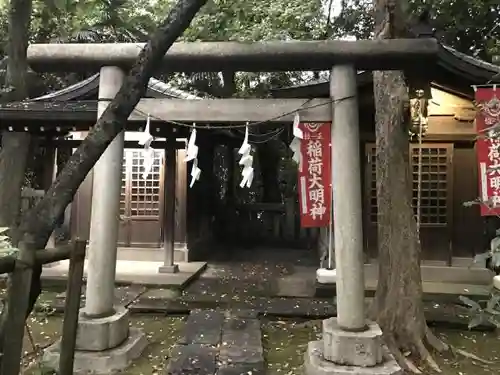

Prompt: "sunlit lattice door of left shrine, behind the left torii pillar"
[119,149,164,247]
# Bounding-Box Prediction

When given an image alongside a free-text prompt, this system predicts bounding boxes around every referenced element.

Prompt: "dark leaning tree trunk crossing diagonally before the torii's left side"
[0,0,207,358]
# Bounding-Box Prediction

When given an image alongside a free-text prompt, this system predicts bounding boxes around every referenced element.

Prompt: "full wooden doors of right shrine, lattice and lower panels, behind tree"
[364,143,453,262]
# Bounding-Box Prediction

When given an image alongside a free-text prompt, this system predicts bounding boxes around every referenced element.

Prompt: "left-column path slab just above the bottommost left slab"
[179,310,224,345]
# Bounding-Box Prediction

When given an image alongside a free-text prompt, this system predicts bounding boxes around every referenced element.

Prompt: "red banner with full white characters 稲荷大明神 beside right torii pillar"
[298,123,332,228]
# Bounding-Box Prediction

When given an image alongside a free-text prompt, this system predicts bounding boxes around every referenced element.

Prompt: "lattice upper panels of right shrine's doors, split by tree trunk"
[366,144,453,226]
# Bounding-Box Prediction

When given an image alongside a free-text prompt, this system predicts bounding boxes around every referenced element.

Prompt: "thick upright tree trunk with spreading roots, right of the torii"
[371,0,446,370]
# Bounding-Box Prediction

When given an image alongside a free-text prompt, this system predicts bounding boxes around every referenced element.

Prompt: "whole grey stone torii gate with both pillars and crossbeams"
[28,39,439,375]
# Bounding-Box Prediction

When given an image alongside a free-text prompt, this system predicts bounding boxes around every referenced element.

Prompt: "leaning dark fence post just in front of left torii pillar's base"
[59,239,87,375]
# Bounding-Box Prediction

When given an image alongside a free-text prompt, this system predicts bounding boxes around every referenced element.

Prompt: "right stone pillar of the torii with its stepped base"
[304,65,402,375]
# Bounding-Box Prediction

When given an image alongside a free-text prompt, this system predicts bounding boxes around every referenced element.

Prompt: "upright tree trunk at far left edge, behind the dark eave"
[0,0,32,231]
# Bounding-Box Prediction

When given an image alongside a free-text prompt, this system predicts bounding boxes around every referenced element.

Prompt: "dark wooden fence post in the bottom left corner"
[0,237,35,375]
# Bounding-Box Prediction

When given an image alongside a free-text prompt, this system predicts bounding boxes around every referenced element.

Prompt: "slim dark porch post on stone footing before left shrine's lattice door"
[159,134,179,273]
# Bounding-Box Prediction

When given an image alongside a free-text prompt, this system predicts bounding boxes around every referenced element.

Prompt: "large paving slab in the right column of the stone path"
[219,318,264,367]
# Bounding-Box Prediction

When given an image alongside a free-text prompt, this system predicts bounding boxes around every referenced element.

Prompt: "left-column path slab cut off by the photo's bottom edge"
[165,344,217,375]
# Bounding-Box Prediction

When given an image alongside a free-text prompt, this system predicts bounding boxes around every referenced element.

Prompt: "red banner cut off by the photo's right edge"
[476,86,500,216]
